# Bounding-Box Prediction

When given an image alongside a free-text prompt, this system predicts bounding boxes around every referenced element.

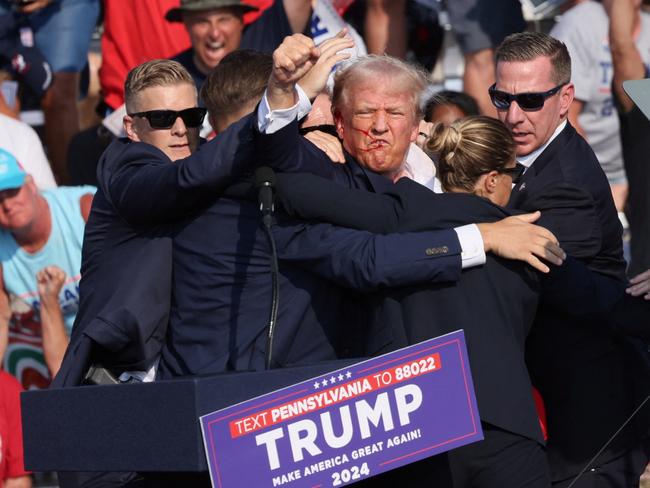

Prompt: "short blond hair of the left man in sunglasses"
[124,59,196,113]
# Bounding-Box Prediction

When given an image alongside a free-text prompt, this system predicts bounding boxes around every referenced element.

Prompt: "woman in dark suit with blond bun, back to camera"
[270,117,648,486]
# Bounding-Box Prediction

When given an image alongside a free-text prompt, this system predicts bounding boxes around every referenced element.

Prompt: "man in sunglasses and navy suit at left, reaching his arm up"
[54,60,250,392]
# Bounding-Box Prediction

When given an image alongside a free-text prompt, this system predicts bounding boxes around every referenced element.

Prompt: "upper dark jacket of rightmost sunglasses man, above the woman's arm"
[508,123,625,280]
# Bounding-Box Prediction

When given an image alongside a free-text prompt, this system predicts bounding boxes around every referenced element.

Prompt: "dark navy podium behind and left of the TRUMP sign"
[21,360,356,472]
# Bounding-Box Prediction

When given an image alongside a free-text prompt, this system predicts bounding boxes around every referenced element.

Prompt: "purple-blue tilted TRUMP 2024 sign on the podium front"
[201,331,483,488]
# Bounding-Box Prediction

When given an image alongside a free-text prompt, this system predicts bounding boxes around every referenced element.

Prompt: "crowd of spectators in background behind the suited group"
[0,0,650,488]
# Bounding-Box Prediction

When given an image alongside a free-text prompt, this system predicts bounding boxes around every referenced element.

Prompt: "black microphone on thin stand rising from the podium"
[254,166,280,369]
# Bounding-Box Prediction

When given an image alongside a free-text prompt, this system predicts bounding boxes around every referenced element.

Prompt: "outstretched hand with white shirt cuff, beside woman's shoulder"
[478,212,566,273]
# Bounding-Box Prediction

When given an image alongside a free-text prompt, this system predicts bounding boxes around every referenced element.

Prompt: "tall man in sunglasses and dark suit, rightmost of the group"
[489,33,645,487]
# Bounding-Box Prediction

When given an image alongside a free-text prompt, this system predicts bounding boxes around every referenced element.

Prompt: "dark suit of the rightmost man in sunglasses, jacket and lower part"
[509,123,638,480]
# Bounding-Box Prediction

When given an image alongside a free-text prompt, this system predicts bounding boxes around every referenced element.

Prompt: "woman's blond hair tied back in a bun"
[426,115,516,193]
